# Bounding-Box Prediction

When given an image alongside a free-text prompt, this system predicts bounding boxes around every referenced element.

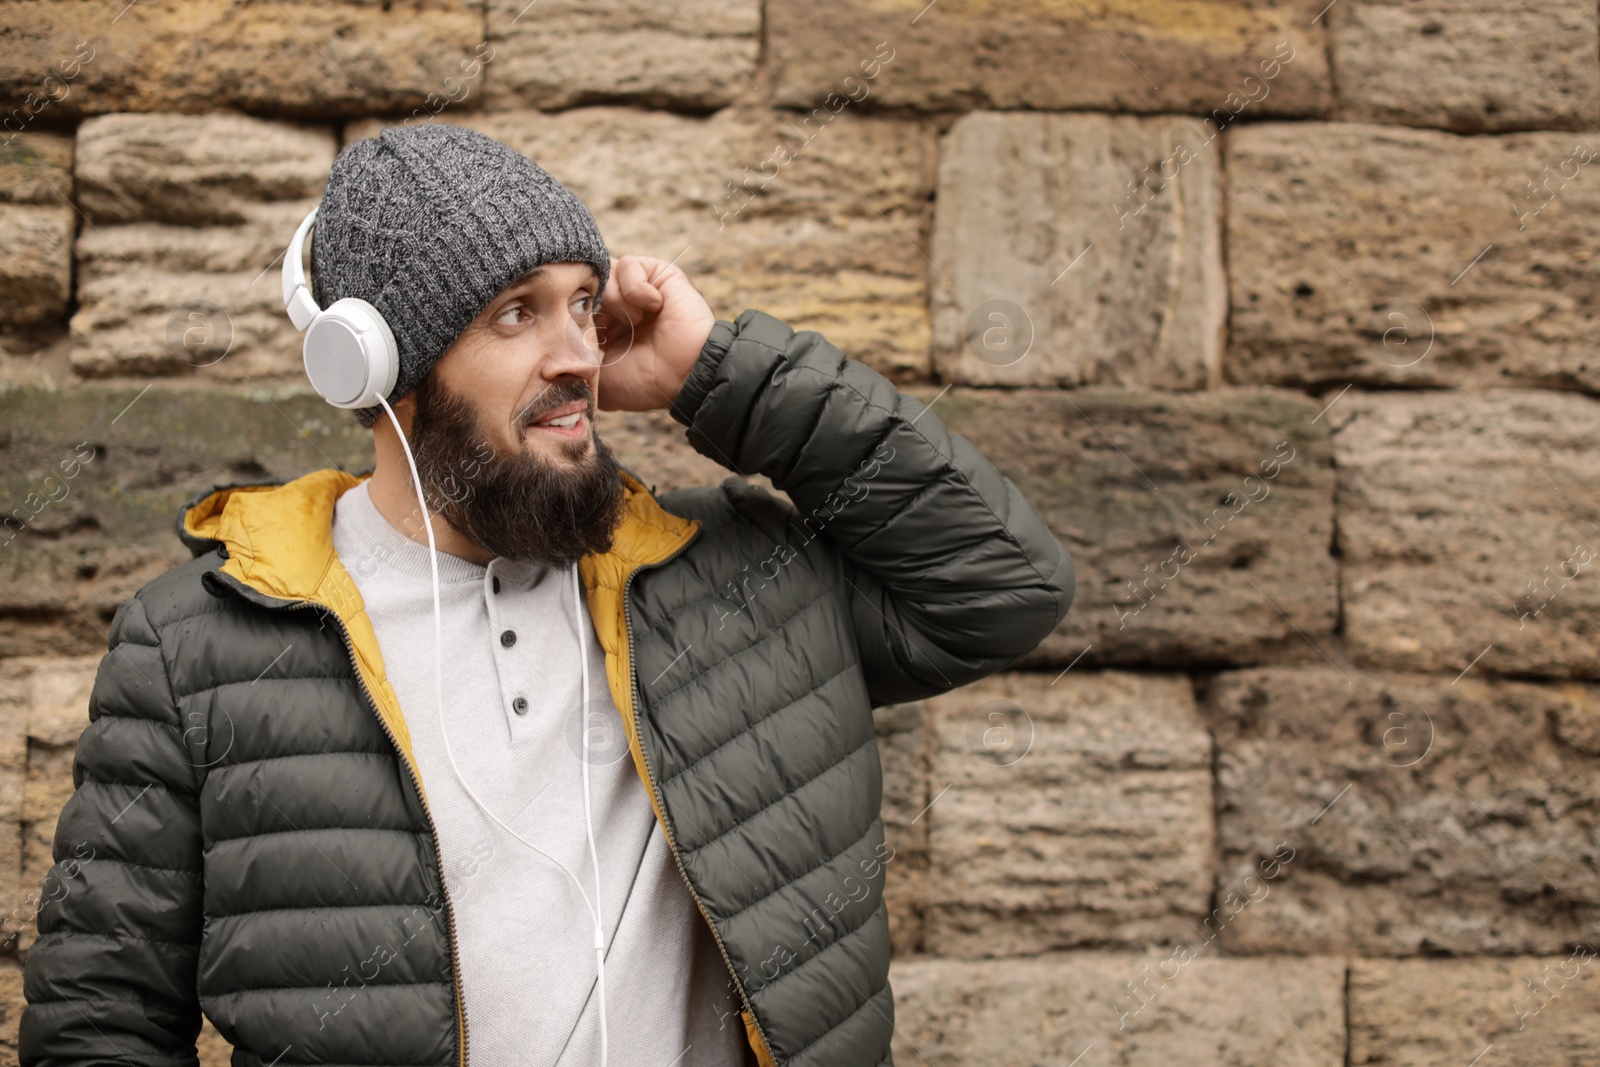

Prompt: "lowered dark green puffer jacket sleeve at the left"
[18,598,203,1067]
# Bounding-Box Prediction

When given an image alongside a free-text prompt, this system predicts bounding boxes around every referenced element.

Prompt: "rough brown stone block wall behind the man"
[0,0,1600,1067]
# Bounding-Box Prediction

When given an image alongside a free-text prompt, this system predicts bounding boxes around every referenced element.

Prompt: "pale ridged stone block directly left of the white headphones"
[72,114,336,379]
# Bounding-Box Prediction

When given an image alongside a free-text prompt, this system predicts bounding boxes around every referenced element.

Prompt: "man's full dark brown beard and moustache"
[411,374,622,566]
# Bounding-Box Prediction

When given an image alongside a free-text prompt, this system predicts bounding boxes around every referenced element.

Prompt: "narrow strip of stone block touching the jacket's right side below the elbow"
[872,704,931,957]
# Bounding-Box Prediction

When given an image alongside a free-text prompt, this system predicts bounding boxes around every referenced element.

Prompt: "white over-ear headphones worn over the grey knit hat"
[283,208,400,408]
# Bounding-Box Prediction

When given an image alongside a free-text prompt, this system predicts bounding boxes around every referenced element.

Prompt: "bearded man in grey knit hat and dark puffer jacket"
[21,126,1074,1067]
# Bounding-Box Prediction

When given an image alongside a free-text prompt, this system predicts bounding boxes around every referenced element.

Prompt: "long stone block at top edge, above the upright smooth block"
[766,0,1331,115]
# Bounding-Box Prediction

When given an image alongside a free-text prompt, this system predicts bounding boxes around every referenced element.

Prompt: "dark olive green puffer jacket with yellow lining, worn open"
[21,310,1074,1067]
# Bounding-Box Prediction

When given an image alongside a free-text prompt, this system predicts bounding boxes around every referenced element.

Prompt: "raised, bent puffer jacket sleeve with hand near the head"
[672,309,1074,704]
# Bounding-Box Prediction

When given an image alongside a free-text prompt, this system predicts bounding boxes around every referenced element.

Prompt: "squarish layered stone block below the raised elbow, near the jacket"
[923,672,1216,957]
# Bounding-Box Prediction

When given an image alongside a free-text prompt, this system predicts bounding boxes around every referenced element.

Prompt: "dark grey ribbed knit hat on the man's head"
[310,123,611,426]
